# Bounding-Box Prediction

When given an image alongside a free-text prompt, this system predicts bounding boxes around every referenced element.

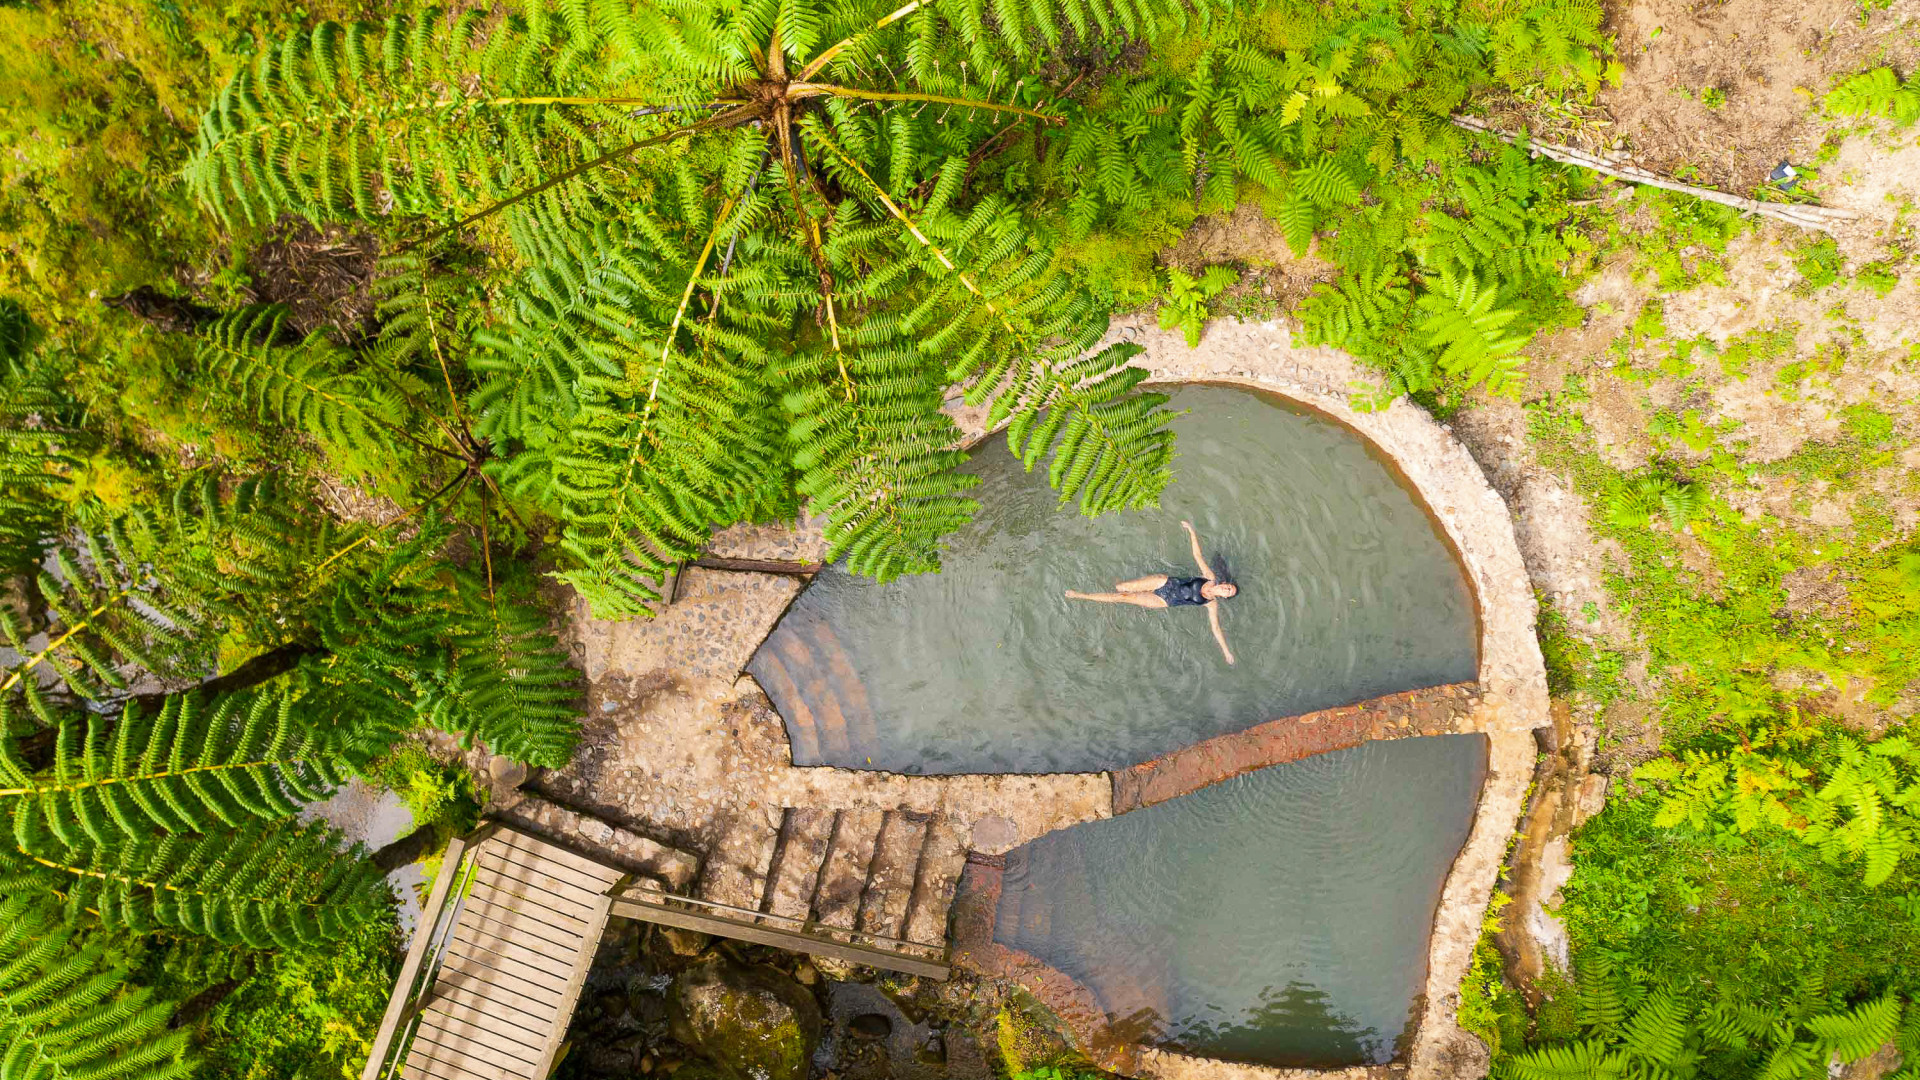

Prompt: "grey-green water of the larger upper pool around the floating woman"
[749,386,1476,773]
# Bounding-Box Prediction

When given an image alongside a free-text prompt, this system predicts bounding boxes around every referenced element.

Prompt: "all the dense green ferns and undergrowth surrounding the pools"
[0,0,1920,1076]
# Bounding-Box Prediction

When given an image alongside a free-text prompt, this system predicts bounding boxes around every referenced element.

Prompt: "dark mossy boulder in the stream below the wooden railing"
[668,957,820,1080]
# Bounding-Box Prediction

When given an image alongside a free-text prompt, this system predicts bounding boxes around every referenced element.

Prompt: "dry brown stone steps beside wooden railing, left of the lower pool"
[693,809,968,955]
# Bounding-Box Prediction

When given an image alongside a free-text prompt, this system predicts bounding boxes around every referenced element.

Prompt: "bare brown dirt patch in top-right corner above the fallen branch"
[1599,0,1920,194]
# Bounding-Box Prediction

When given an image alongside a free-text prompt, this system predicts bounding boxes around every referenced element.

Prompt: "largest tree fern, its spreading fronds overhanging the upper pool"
[188,0,1188,617]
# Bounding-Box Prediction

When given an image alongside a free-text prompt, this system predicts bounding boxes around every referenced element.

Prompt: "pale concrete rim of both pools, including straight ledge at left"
[733,317,1549,1080]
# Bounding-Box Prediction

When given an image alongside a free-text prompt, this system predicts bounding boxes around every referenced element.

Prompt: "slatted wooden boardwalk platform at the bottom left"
[361,822,628,1080]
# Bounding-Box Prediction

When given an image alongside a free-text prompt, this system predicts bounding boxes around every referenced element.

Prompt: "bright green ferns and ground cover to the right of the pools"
[1475,141,1920,1078]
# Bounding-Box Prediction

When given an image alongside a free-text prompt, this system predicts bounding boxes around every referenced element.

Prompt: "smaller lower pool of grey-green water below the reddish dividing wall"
[995,736,1488,1068]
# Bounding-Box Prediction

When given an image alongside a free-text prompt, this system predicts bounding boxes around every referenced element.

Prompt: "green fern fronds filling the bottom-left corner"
[0,896,198,1080]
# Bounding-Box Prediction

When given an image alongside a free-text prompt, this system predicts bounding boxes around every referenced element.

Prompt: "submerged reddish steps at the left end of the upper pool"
[747,611,877,765]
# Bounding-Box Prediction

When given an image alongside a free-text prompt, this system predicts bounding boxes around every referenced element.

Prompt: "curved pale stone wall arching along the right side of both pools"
[936,317,1549,1080]
